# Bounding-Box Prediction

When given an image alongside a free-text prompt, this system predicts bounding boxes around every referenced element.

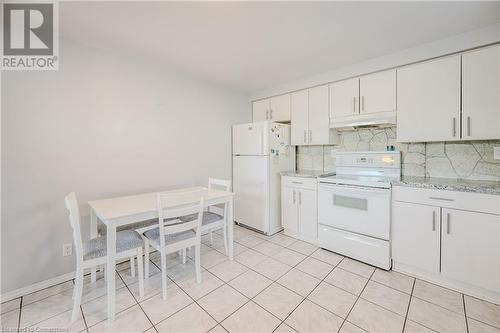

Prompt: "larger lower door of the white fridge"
[233,156,269,233]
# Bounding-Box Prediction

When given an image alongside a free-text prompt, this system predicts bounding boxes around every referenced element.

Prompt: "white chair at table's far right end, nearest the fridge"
[180,178,231,254]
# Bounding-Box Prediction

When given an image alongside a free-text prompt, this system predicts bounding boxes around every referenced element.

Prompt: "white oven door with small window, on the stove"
[318,183,391,240]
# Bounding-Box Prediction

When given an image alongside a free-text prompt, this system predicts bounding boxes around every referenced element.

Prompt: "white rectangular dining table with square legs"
[88,186,234,322]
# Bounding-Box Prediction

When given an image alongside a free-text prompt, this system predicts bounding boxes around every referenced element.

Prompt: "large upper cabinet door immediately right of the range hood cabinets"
[397,56,460,142]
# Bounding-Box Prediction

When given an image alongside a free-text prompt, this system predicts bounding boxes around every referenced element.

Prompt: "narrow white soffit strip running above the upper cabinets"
[251,23,500,100]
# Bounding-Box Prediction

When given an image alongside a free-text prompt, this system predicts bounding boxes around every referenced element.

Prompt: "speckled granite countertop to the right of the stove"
[392,176,500,195]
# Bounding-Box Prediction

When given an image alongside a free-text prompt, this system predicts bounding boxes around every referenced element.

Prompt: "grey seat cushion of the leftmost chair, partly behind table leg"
[83,230,144,260]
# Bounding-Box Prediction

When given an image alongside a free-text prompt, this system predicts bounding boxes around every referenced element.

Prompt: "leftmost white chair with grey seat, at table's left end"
[64,192,144,321]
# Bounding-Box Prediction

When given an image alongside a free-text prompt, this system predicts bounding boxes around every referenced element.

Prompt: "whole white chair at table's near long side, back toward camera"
[143,189,206,300]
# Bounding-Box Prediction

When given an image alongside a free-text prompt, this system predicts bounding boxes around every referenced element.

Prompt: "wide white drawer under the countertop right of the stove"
[392,186,500,215]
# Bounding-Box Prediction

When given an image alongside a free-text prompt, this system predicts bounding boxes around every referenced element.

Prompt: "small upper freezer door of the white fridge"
[233,121,269,155]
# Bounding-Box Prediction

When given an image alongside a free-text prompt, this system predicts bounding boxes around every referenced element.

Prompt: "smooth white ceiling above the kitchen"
[59,1,500,92]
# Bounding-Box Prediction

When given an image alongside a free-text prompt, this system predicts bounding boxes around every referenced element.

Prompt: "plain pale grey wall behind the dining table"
[1,41,251,294]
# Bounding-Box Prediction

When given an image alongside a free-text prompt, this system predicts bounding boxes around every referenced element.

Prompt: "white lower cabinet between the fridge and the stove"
[281,176,318,243]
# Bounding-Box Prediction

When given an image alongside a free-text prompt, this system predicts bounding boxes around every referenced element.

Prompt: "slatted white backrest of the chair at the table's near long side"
[157,188,207,247]
